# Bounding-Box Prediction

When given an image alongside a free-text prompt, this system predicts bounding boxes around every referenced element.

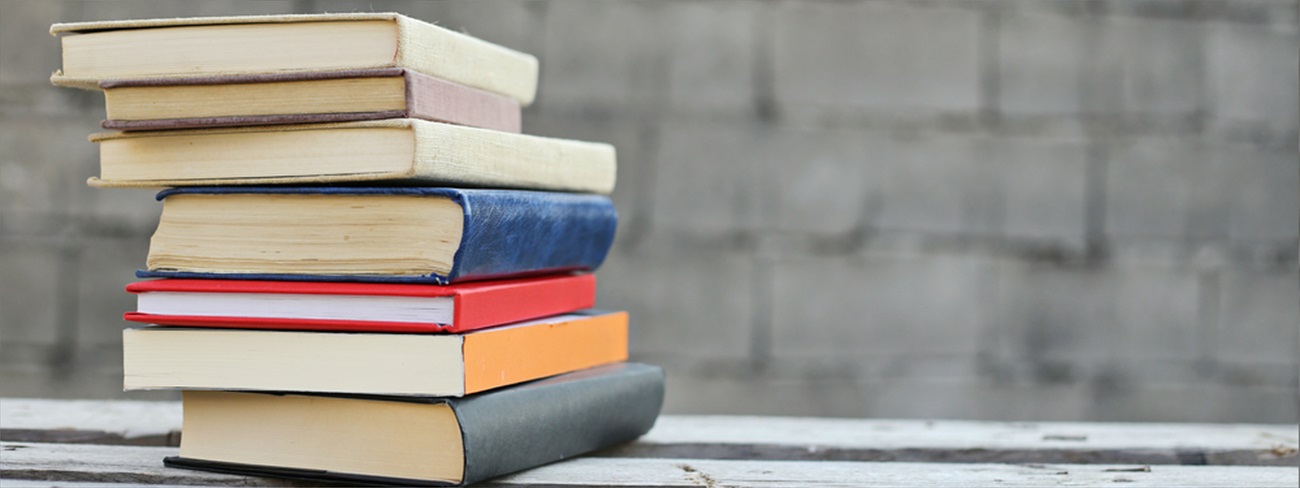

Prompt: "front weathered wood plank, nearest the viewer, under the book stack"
[0,442,1300,488]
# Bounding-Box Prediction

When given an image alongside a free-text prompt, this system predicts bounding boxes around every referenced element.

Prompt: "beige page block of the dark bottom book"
[178,390,465,484]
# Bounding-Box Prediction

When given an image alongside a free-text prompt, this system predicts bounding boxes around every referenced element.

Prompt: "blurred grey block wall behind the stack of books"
[0,0,1300,422]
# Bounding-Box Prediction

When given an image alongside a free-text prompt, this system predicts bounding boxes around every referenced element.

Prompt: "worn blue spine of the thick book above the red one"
[449,190,618,281]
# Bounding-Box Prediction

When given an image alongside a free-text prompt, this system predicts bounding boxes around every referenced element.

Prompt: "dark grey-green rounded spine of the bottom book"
[450,363,663,484]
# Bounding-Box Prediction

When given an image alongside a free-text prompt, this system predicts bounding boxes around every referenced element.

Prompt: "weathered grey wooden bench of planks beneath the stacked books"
[0,400,1300,488]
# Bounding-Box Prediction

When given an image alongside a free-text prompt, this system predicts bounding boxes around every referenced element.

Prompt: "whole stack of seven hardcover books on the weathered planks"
[51,13,663,484]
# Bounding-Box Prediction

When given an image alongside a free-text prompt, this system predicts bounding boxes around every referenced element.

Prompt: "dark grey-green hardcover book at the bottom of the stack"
[164,363,664,485]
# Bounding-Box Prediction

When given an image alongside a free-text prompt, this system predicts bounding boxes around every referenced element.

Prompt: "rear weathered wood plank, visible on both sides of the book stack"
[0,400,1300,466]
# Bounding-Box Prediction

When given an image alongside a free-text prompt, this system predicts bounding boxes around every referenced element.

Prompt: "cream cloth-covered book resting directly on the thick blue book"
[90,118,615,194]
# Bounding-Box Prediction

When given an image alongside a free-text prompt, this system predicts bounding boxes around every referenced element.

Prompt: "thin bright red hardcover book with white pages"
[122,275,595,333]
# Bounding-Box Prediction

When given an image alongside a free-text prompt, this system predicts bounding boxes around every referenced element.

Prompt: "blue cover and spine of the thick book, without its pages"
[135,186,618,285]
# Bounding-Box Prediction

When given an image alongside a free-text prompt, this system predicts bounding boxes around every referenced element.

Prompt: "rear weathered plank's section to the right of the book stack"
[601,416,1300,466]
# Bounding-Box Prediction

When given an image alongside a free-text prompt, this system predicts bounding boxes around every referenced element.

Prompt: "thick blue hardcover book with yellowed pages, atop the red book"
[137,186,618,285]
